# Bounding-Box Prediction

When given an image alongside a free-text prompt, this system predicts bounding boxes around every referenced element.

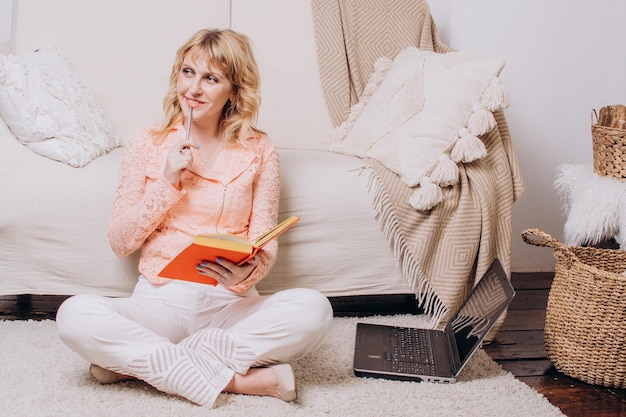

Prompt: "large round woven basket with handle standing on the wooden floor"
[522,229,626,388]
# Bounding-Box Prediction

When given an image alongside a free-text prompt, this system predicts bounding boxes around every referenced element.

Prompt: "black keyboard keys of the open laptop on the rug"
[385,327,435,375]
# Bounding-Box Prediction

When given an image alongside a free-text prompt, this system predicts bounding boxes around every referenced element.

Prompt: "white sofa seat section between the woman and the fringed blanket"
[257,149,413,296]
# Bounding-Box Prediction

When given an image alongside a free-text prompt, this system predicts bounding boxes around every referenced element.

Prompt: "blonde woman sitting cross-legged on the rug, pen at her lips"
[57,30,332,406]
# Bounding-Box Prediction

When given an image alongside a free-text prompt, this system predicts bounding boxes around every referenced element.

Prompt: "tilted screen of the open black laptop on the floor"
[450,259,515,367]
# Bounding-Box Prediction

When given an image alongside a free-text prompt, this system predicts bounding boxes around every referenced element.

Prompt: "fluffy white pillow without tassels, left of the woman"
[0,46,121,167]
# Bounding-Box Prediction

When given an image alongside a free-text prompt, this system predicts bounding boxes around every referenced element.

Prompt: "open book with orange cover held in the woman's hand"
[159,216,300,285]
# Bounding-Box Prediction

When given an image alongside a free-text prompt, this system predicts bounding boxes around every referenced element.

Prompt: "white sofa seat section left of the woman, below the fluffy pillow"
[0,120,139,296]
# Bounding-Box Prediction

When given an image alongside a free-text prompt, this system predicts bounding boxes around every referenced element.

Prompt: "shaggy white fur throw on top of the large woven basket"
[554,164,626,249]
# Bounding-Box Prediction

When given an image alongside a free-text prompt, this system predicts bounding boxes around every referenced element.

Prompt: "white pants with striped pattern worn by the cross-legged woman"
[57,277,332,405]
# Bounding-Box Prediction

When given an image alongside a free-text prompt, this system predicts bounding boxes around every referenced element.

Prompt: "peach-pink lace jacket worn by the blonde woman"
[108,125,280,293]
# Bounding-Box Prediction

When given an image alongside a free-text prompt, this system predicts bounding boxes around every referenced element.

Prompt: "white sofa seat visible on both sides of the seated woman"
[0,120,412,296]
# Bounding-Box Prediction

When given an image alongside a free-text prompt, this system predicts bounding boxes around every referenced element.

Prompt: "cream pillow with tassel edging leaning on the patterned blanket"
[326,47,508,210]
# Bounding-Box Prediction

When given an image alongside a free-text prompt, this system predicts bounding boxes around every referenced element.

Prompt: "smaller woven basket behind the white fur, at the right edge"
[591,109,626,181]
